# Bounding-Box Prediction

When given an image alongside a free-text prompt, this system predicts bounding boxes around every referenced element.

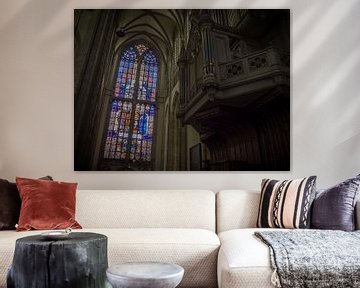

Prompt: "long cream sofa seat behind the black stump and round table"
[0,228,220,288]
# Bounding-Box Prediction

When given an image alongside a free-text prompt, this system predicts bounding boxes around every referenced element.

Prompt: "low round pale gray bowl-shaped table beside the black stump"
[106,262,184,288]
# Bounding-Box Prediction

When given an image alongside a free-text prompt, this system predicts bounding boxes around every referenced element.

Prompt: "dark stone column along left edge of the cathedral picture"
[74,10,116,171]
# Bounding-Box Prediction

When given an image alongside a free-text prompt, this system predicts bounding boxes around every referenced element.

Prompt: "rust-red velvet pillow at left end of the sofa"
[16,177,81,231]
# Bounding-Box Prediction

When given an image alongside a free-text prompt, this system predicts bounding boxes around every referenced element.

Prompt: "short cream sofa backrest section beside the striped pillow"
[216,190,260,233]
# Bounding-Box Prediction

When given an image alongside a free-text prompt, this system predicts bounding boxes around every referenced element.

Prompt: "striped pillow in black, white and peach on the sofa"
[257,176,316,229]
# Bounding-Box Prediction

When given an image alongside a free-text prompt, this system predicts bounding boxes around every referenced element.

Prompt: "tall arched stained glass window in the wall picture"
[104,44,158,162]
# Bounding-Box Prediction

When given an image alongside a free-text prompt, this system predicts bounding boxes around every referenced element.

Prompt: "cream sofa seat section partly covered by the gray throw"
[217,228,274,288]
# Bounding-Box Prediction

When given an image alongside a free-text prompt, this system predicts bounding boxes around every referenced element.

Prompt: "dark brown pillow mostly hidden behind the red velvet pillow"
[0,176,52,230]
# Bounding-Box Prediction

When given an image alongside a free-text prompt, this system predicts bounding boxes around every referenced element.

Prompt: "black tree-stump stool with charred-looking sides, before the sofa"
[7,232,108,288]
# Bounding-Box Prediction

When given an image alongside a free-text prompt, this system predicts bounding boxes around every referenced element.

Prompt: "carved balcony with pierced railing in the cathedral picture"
[180,47,290,123]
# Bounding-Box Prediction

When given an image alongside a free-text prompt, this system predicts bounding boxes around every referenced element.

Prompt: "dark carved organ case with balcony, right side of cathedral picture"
[178,10,290,171]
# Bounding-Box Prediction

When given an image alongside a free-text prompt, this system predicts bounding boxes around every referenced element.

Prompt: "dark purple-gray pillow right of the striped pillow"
[311,175,360,231]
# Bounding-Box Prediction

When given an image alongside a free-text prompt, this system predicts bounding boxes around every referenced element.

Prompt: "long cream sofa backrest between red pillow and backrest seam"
[76,190,215,231]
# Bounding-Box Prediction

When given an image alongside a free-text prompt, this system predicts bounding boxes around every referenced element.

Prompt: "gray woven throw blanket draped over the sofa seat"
[255,229,360,288]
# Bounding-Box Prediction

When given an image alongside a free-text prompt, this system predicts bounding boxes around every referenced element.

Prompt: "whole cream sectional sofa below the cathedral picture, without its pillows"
[0,190,360,288]
